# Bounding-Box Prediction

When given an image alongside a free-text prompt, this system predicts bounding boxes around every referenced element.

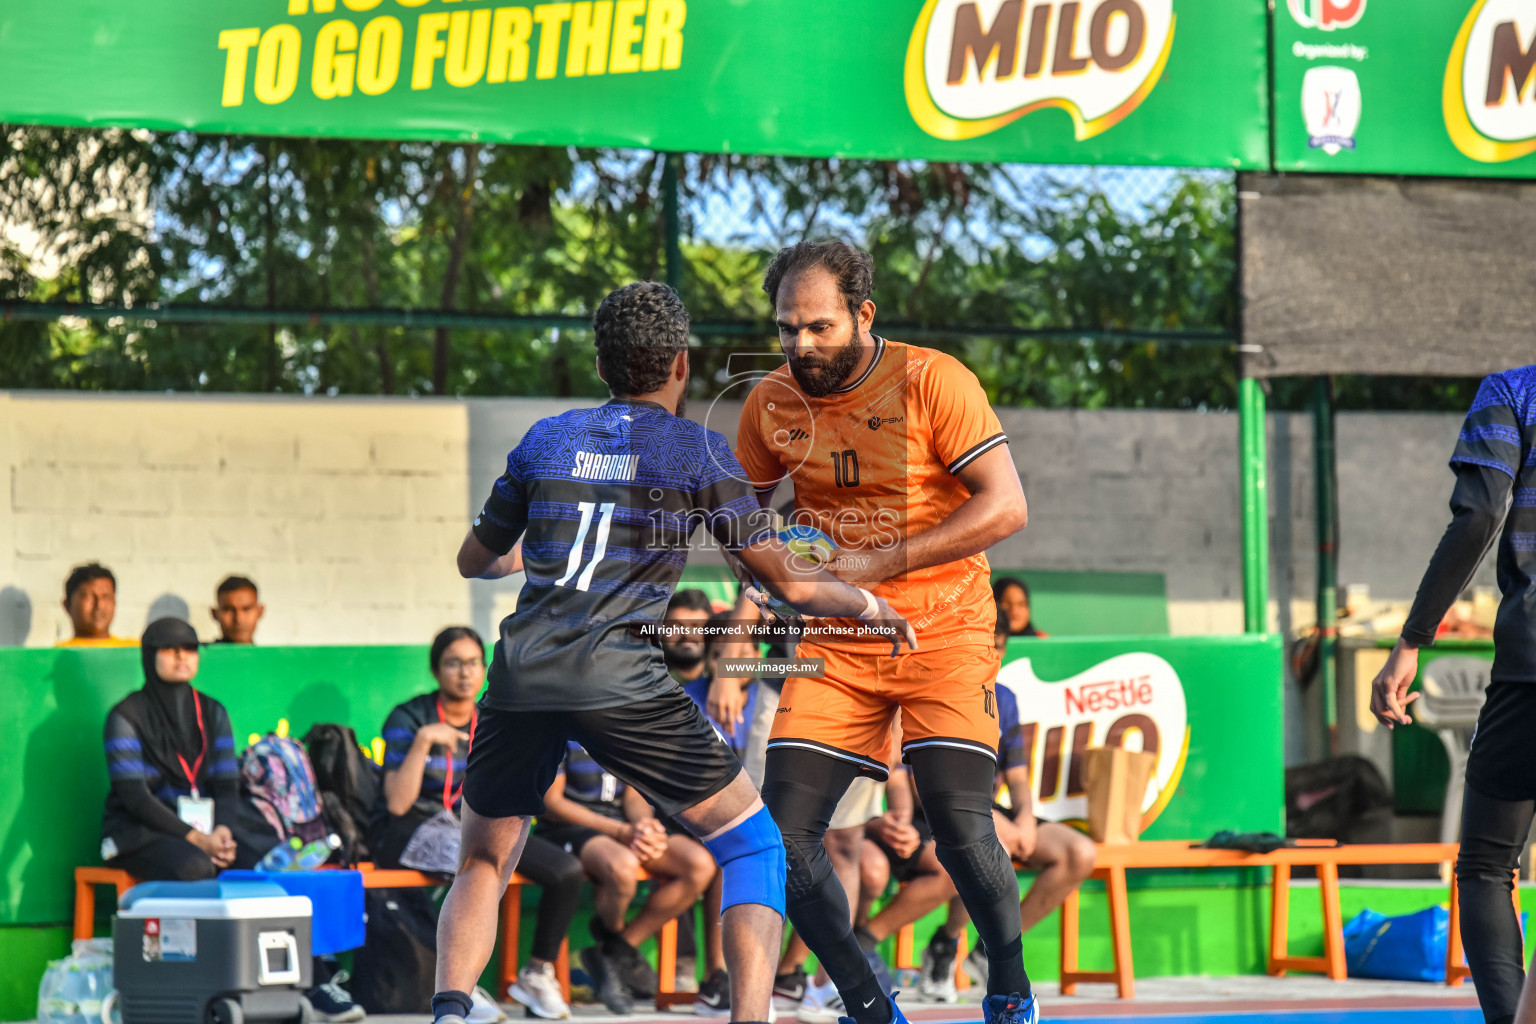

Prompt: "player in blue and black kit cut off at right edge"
[1370,365,1536,1024]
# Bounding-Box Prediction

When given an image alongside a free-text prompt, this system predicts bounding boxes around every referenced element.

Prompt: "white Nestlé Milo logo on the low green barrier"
[997,652,1189,827]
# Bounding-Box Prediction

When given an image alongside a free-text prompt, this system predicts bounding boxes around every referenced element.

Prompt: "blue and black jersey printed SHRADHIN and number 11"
[473,399,773,711]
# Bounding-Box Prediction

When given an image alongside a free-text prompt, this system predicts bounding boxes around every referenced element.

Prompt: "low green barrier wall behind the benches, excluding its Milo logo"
[0,636,1283,1021]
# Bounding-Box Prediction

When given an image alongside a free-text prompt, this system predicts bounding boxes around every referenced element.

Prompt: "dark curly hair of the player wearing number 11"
[591,281,688,398]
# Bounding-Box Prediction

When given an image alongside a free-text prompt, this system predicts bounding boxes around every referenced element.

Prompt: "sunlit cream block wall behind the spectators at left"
[0,393,468,645]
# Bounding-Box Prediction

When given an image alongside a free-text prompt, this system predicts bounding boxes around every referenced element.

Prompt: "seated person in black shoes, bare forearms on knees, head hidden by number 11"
[533,743,714,1013]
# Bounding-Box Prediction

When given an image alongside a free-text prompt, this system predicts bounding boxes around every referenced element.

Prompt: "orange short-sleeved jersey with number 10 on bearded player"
[736,338,1008,649]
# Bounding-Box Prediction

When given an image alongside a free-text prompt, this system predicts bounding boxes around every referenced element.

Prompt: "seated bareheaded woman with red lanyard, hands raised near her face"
[369,626,585,1019]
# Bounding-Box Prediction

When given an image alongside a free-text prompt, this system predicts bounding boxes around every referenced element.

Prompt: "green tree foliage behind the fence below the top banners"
[0,127,1464,408]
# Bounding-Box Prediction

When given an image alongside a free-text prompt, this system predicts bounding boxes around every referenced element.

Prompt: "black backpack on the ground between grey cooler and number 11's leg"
[350,889,438,1013]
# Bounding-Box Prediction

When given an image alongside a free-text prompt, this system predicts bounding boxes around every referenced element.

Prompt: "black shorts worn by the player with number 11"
[464,686,742,818]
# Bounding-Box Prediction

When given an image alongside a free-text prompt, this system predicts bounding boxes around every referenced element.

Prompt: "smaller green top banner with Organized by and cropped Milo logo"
[1273,0,1536,178]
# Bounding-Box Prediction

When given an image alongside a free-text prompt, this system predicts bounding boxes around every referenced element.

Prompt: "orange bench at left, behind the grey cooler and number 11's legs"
[74,863,696,1010]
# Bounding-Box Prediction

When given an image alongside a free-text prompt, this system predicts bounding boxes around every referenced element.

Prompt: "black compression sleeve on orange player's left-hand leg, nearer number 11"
[762,748,897,1024]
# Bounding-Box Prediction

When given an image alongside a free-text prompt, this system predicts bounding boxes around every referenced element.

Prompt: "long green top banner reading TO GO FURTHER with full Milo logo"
[0,0,1271,169]
